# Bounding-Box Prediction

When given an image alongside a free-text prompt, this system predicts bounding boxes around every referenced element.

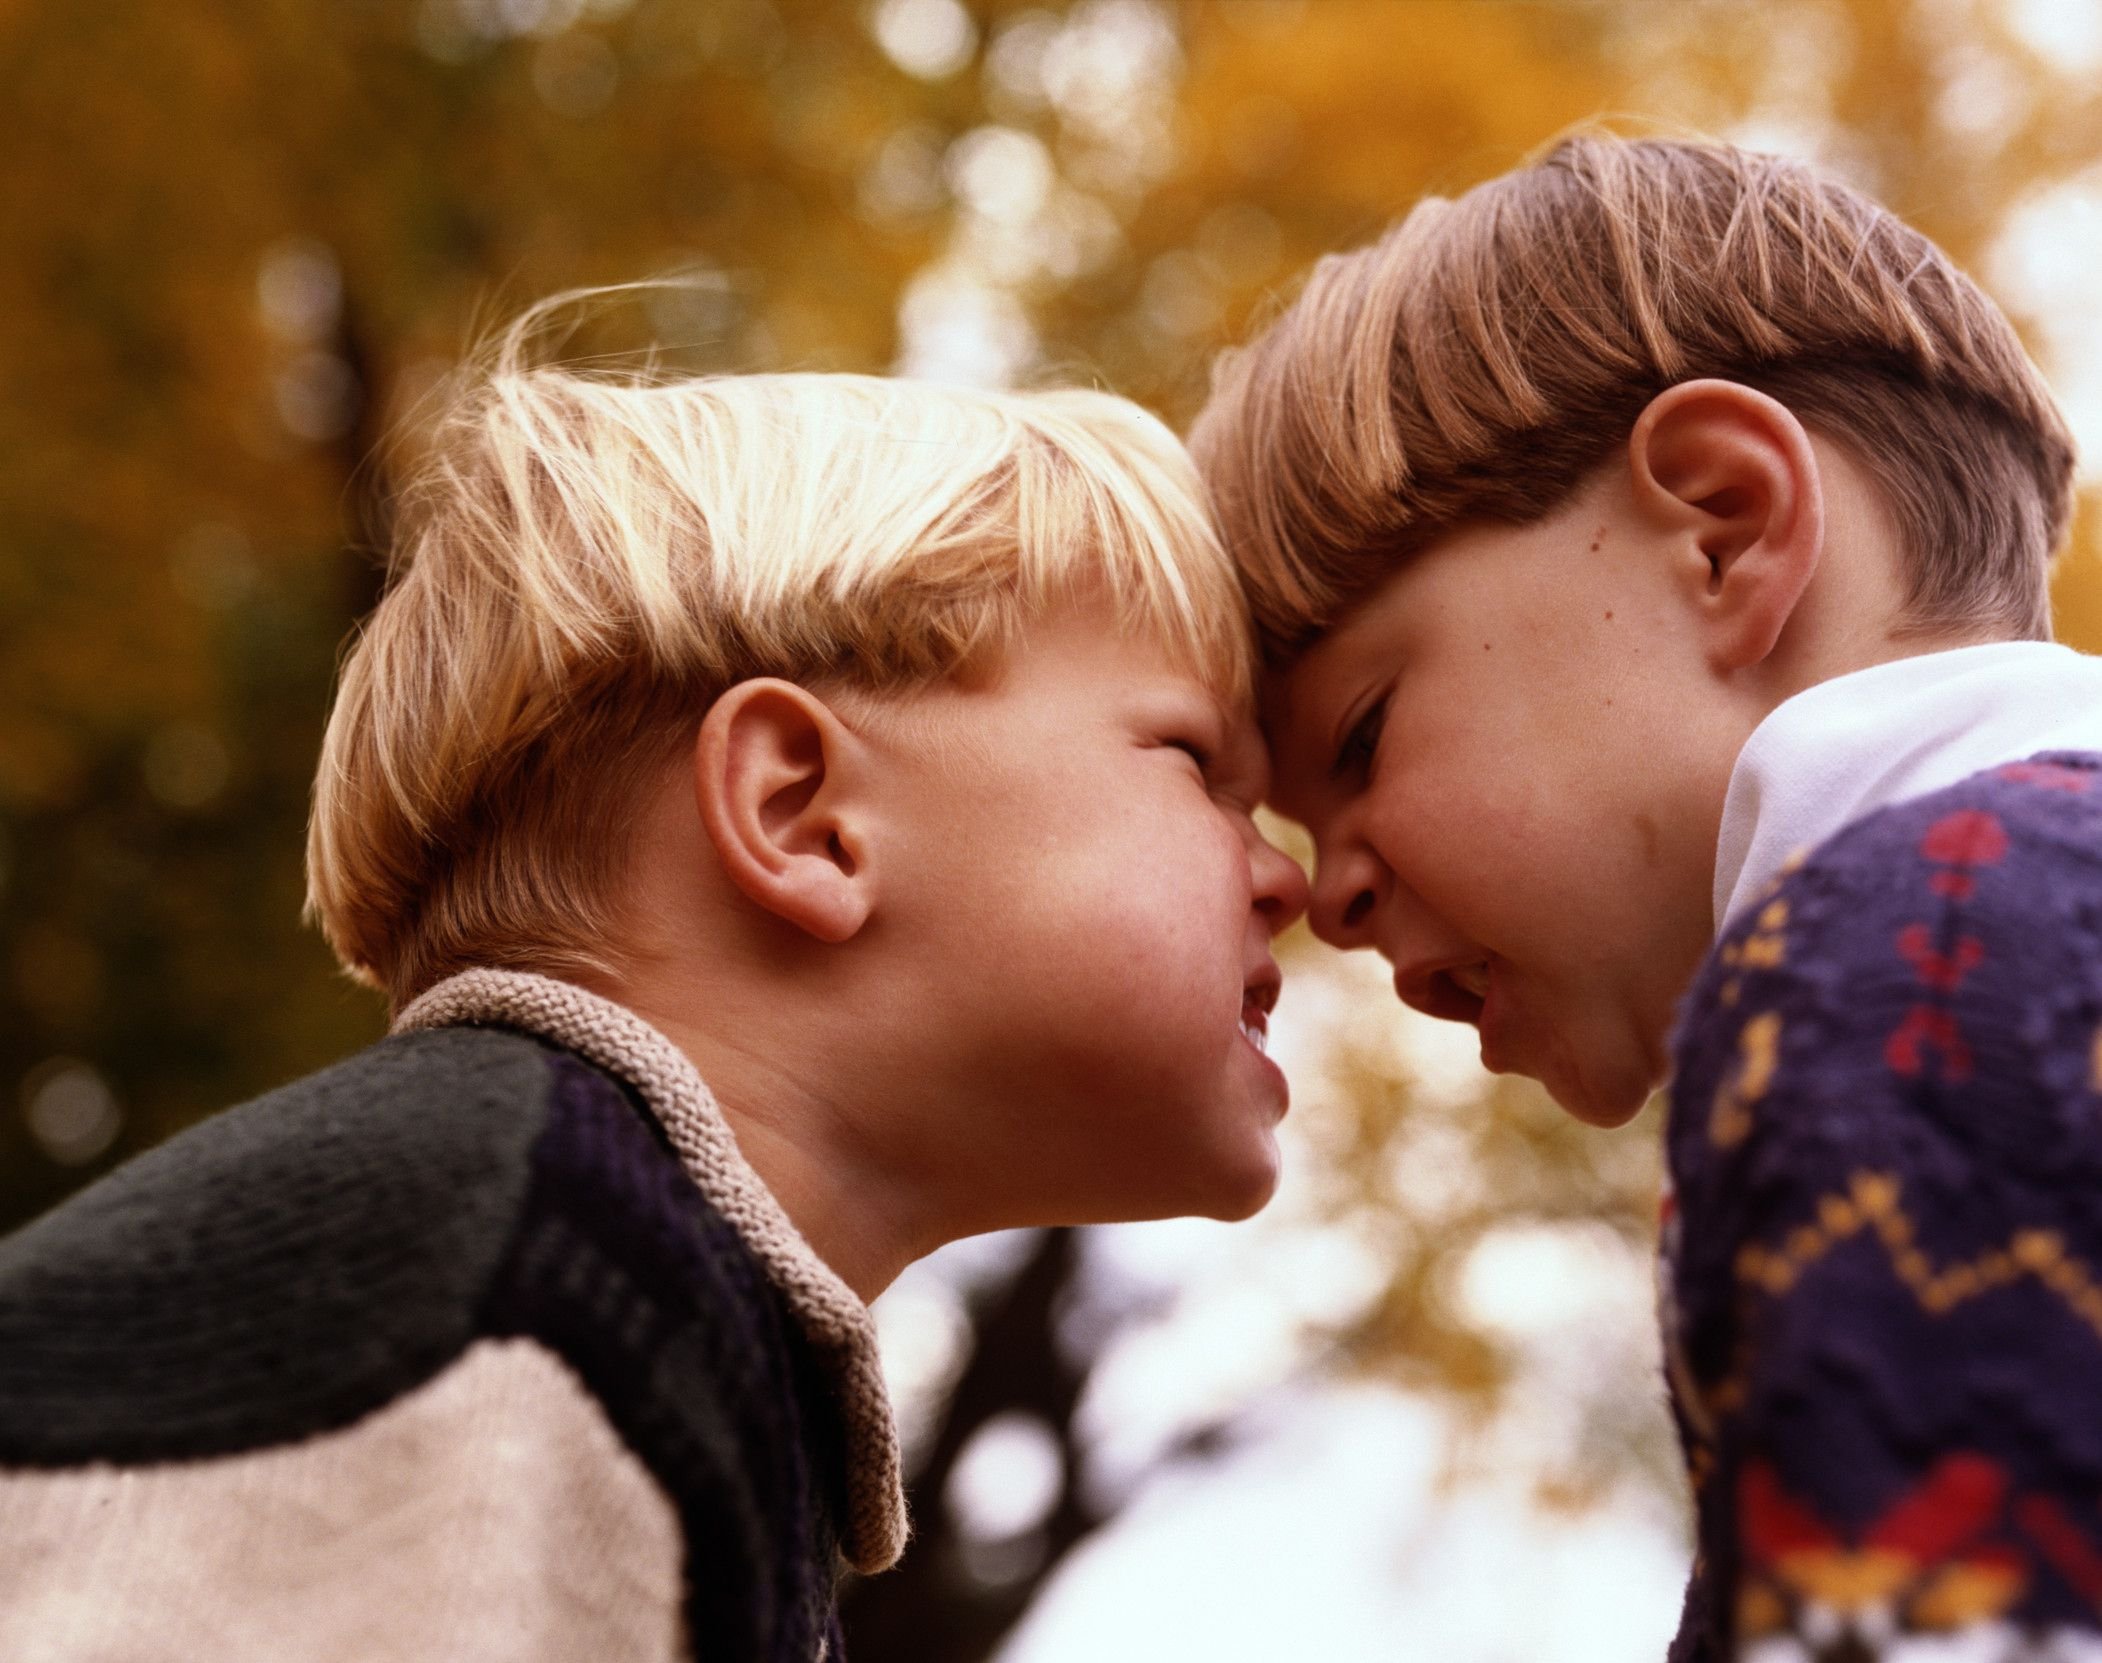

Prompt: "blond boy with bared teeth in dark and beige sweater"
[0,304,1305,1663]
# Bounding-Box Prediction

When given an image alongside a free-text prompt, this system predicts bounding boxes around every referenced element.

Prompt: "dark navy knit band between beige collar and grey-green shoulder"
[489,1055,845,1663]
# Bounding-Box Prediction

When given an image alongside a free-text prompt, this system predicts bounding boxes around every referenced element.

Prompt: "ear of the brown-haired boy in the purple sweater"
[1627,381,1825,671]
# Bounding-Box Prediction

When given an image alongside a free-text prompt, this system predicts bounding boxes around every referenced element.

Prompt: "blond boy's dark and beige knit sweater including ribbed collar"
[0,971,904,1663]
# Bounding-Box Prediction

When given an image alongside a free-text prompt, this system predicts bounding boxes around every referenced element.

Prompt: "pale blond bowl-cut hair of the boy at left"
[307,296,1253,1007]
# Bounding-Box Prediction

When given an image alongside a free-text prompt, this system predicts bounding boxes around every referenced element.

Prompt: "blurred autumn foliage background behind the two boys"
[12,0,2102,1663]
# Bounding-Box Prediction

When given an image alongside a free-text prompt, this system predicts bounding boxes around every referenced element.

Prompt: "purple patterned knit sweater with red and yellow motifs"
[1665,755,2102,1663]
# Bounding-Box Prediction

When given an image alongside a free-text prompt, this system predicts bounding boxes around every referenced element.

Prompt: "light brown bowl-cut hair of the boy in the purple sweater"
[1190,132,2073,662]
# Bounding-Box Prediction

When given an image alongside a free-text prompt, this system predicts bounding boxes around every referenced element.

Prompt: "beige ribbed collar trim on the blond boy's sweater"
[393,969,906,1573]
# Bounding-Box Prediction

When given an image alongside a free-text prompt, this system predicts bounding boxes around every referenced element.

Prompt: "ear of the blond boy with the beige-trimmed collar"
[694,677,874,942]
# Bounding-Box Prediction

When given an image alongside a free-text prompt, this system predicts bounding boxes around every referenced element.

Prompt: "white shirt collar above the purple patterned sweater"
[1715,641,2102,931]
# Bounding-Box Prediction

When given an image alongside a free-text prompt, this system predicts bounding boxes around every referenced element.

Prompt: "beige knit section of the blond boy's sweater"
[0,1339,681,1663]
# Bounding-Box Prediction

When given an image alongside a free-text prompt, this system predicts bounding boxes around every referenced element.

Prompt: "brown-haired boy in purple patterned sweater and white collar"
[1192,137,2102,1663]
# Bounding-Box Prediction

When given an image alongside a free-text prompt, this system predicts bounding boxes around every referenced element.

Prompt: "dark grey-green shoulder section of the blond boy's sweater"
[0,1028,551,1465]
